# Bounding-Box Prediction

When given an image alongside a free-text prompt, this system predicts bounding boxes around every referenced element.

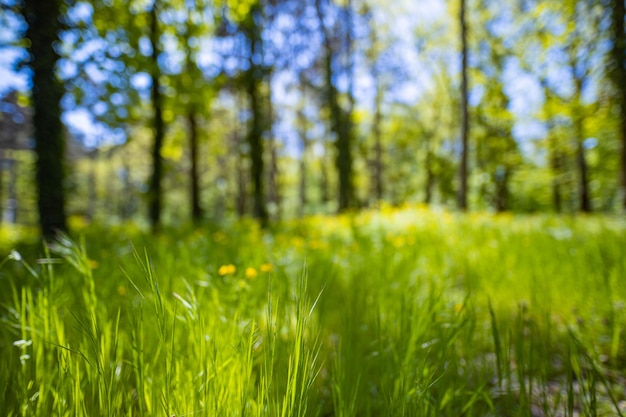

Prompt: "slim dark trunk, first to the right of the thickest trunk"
[149,0,165,231]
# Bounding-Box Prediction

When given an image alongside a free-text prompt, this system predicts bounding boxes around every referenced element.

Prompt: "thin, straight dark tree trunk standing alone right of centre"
[458,0,469,211]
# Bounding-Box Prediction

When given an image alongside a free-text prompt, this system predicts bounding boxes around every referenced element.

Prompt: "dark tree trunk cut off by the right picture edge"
[612,0,626,210]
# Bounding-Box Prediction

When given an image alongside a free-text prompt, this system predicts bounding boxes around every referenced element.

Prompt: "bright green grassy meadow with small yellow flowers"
[0,208,626,417]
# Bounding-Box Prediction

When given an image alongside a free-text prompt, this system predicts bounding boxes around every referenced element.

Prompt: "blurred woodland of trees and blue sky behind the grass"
[0,0,626,229]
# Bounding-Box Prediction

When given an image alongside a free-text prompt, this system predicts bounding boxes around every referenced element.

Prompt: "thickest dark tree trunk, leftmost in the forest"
[23,0,67,238]
